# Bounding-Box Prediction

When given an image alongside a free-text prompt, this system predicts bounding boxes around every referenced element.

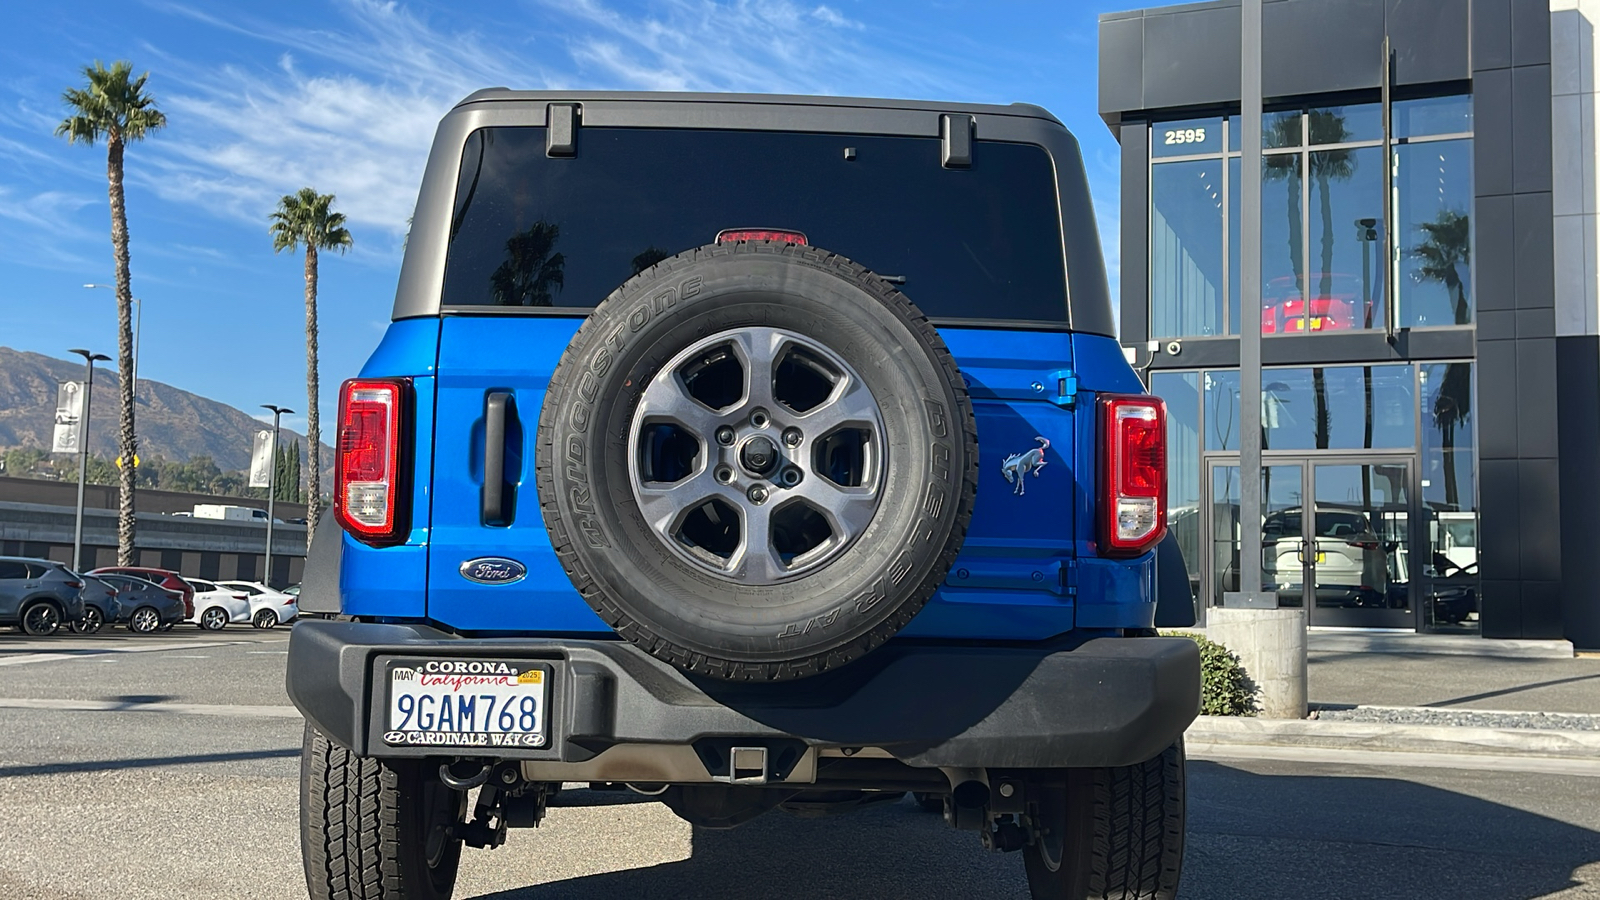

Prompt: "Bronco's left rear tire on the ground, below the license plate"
[301,724,466,900]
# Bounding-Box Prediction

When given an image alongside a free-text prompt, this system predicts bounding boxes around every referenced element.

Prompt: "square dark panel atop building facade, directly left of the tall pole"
[1144,6,1240,109]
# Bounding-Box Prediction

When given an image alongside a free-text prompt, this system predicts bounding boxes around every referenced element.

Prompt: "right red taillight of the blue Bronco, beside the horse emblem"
[1099,394,1166,556]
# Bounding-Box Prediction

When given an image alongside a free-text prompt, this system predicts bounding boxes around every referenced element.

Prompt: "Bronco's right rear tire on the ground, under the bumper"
[1022,738,1184,900]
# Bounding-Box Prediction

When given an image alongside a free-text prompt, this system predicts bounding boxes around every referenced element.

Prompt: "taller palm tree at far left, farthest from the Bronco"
[56,59,166,565]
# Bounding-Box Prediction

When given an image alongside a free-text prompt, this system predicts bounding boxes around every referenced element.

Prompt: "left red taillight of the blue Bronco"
[333,380,410,544]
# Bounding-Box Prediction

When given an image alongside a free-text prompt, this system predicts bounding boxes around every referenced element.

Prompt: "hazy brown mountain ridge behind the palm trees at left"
[0,348,333,471]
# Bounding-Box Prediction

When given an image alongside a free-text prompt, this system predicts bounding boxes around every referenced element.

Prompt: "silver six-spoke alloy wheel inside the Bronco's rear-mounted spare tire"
[627,327,886,585]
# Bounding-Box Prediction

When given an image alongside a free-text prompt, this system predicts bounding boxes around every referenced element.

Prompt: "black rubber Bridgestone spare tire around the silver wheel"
[536,242,978,681]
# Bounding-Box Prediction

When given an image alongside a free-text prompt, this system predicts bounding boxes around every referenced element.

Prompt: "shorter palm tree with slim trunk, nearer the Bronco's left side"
[267,187,354,549]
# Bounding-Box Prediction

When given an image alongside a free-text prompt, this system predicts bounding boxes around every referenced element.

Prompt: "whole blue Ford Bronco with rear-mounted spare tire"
[288,88,1200,900]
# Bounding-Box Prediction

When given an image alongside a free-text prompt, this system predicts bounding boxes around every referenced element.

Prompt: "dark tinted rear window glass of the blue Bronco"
[442,128,1067,322]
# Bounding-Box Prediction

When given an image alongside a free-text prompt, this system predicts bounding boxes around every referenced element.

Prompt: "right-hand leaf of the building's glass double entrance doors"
[1302,458,1416,628]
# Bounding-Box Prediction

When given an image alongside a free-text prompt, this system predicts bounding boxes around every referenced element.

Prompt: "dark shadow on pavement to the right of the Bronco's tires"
[1179,761,1600,900]
